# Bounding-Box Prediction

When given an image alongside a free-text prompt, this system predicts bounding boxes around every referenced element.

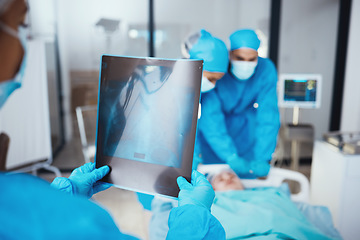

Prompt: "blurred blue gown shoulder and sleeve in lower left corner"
[0,173,137,240]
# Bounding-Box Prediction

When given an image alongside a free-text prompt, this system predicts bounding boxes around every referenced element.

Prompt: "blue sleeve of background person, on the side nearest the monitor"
[254,60,280,161]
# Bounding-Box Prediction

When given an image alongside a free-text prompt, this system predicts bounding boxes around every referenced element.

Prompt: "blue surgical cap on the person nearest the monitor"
[230,29,260,51]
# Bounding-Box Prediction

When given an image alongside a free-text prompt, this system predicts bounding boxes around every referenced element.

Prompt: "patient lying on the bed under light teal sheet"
[150,169,341,240]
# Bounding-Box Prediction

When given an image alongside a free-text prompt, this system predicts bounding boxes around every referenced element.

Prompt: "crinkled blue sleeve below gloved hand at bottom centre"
[166,204,225,240]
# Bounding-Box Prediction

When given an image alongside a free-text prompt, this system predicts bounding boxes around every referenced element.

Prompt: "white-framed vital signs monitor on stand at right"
[279,74,322,108]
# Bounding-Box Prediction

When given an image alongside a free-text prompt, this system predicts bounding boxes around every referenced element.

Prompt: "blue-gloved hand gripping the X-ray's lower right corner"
[177,170,215,211]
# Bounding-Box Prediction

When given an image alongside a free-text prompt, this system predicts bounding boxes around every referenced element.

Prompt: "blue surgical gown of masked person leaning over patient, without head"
[196,57,280,163]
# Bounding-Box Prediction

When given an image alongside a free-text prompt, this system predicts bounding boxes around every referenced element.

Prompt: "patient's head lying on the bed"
[208,169,244,191]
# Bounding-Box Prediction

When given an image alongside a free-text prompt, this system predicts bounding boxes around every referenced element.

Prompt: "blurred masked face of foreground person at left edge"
[0,0,28,108]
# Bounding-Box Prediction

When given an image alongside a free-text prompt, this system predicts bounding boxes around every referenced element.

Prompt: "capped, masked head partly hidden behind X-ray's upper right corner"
[184,30,229,92]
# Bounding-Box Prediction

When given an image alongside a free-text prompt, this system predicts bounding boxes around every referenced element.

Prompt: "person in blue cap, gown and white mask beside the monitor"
[198,29,280,178]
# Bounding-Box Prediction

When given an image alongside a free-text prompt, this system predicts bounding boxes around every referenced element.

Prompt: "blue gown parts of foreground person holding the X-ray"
[0,172,225,240]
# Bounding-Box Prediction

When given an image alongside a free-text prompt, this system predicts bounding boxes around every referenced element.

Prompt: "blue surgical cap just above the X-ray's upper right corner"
[189,30,229,73]
